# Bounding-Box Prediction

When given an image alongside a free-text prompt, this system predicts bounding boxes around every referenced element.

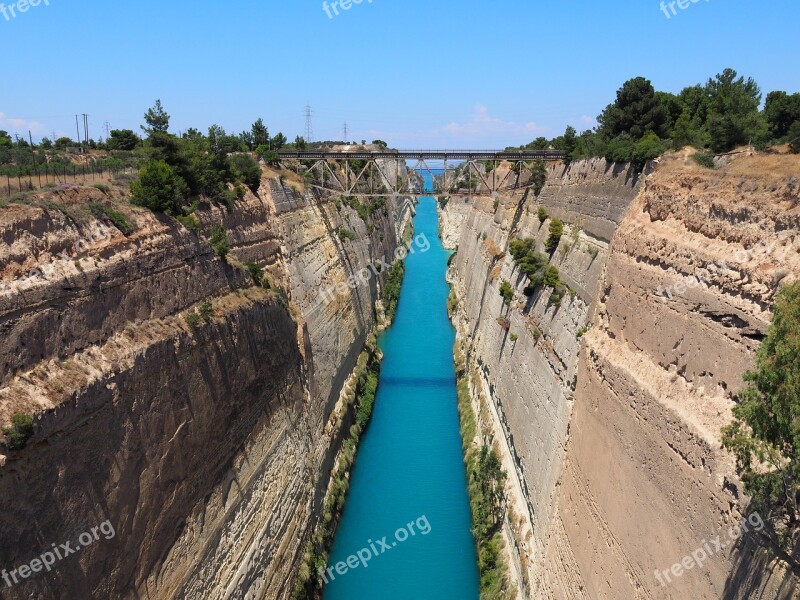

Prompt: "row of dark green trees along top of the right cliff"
[512,69,800,170]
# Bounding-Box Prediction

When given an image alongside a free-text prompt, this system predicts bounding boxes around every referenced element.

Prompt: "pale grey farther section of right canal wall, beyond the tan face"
[442,161,638,593]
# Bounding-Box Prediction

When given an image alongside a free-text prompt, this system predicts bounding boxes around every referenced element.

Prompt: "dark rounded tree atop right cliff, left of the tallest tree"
[597,77,668,140]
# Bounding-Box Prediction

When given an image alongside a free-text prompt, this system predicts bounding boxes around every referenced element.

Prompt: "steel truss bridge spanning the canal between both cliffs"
[278,150,564,197]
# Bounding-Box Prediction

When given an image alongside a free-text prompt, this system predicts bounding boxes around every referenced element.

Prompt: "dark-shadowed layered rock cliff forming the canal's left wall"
[0,166,410,599]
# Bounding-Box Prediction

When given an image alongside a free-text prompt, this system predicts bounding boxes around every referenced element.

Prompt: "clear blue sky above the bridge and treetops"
[0,0,800,148]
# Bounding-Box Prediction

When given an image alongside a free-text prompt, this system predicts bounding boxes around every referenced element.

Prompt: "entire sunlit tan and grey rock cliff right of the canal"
[443,155,800,599]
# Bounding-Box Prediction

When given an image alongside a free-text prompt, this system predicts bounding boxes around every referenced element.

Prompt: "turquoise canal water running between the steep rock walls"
[324,182,478,600]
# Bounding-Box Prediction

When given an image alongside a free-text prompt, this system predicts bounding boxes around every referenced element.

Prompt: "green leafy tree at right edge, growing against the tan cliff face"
[722,282,800,541]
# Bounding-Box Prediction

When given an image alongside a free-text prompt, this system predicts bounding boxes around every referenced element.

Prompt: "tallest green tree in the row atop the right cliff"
[706,69,767,152]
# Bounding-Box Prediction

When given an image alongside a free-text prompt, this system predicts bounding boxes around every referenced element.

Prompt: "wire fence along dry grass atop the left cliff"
[0,163,139,198]
